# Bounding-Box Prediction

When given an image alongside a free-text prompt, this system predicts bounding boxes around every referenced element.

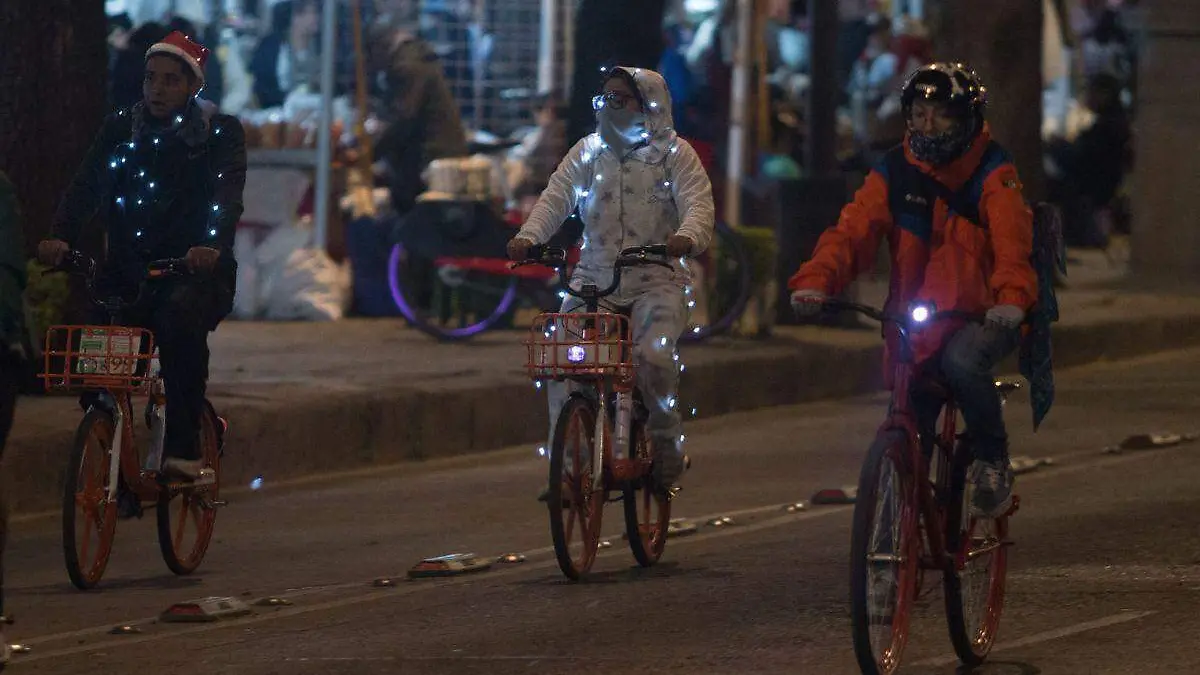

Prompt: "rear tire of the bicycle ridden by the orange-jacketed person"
[942,444,1008,668]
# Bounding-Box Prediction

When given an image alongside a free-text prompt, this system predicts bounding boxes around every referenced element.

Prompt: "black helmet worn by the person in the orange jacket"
[900,62,988,166]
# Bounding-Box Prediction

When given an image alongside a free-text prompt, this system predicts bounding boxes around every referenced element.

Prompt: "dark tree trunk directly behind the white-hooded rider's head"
[566,0,667,145]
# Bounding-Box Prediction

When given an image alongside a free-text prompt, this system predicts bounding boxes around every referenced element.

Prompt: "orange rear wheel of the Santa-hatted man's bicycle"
[157,401,221,575]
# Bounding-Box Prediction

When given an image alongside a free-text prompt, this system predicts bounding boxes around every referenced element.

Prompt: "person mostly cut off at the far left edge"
[0,172,25,670]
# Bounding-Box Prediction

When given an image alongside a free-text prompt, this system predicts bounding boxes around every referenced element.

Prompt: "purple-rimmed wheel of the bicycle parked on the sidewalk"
[388,244,517,340]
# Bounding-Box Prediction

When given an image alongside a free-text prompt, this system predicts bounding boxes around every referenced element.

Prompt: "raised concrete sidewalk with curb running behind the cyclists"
[4,247,1200,513]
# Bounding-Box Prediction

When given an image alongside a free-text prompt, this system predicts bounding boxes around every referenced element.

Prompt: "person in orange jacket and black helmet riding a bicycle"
[788,64,1038,516]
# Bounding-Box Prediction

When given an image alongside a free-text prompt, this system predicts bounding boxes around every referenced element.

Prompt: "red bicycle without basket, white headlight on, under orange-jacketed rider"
[806,299,1020,675]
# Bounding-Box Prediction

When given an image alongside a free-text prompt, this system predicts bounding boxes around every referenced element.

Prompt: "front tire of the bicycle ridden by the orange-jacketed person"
[850,430,920,675]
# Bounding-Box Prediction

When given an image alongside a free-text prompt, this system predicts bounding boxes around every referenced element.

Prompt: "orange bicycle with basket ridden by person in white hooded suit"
[515,245,672,580]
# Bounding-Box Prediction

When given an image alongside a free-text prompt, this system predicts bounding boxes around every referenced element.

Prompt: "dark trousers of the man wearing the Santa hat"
[84,275,234,460]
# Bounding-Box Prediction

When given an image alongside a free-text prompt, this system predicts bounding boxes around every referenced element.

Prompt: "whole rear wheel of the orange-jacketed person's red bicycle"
[942,444,1008,668]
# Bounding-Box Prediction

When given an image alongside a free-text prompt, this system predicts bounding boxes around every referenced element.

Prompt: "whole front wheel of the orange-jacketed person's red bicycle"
[850,431,920,675]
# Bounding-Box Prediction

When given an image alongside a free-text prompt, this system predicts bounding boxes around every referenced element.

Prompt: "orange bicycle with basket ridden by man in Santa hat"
[41,251,228,590]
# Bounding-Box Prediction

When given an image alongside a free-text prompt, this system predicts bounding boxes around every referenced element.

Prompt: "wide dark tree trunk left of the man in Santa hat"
[0,0,108,255]
